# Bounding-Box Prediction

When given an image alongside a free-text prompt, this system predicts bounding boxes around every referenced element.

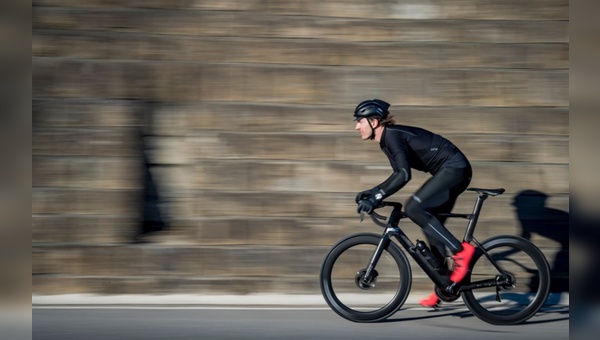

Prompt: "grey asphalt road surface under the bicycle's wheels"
[32,305,569,340]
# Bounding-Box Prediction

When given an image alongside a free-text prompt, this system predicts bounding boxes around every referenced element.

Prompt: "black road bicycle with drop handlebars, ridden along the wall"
[320,188,550,325]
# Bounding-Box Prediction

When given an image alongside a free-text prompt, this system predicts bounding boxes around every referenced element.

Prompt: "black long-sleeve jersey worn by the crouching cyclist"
[378,125,470,197]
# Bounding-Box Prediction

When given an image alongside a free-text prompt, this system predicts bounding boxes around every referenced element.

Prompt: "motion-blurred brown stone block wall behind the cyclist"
[32,0,569,295]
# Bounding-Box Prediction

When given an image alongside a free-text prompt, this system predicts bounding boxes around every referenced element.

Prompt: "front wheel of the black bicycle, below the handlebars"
[319,233,412,322]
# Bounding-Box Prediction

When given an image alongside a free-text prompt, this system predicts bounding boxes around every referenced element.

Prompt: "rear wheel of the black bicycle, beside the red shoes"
[462,236,550,325]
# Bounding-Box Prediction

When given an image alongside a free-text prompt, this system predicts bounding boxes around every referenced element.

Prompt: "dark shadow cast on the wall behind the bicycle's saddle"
[513,190,569,293]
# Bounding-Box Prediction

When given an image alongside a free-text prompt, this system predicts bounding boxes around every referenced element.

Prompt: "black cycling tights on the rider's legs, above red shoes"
[405,167,472,259]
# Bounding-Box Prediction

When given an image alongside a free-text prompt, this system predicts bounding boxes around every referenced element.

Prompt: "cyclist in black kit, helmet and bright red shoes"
[354,99,475,307]
